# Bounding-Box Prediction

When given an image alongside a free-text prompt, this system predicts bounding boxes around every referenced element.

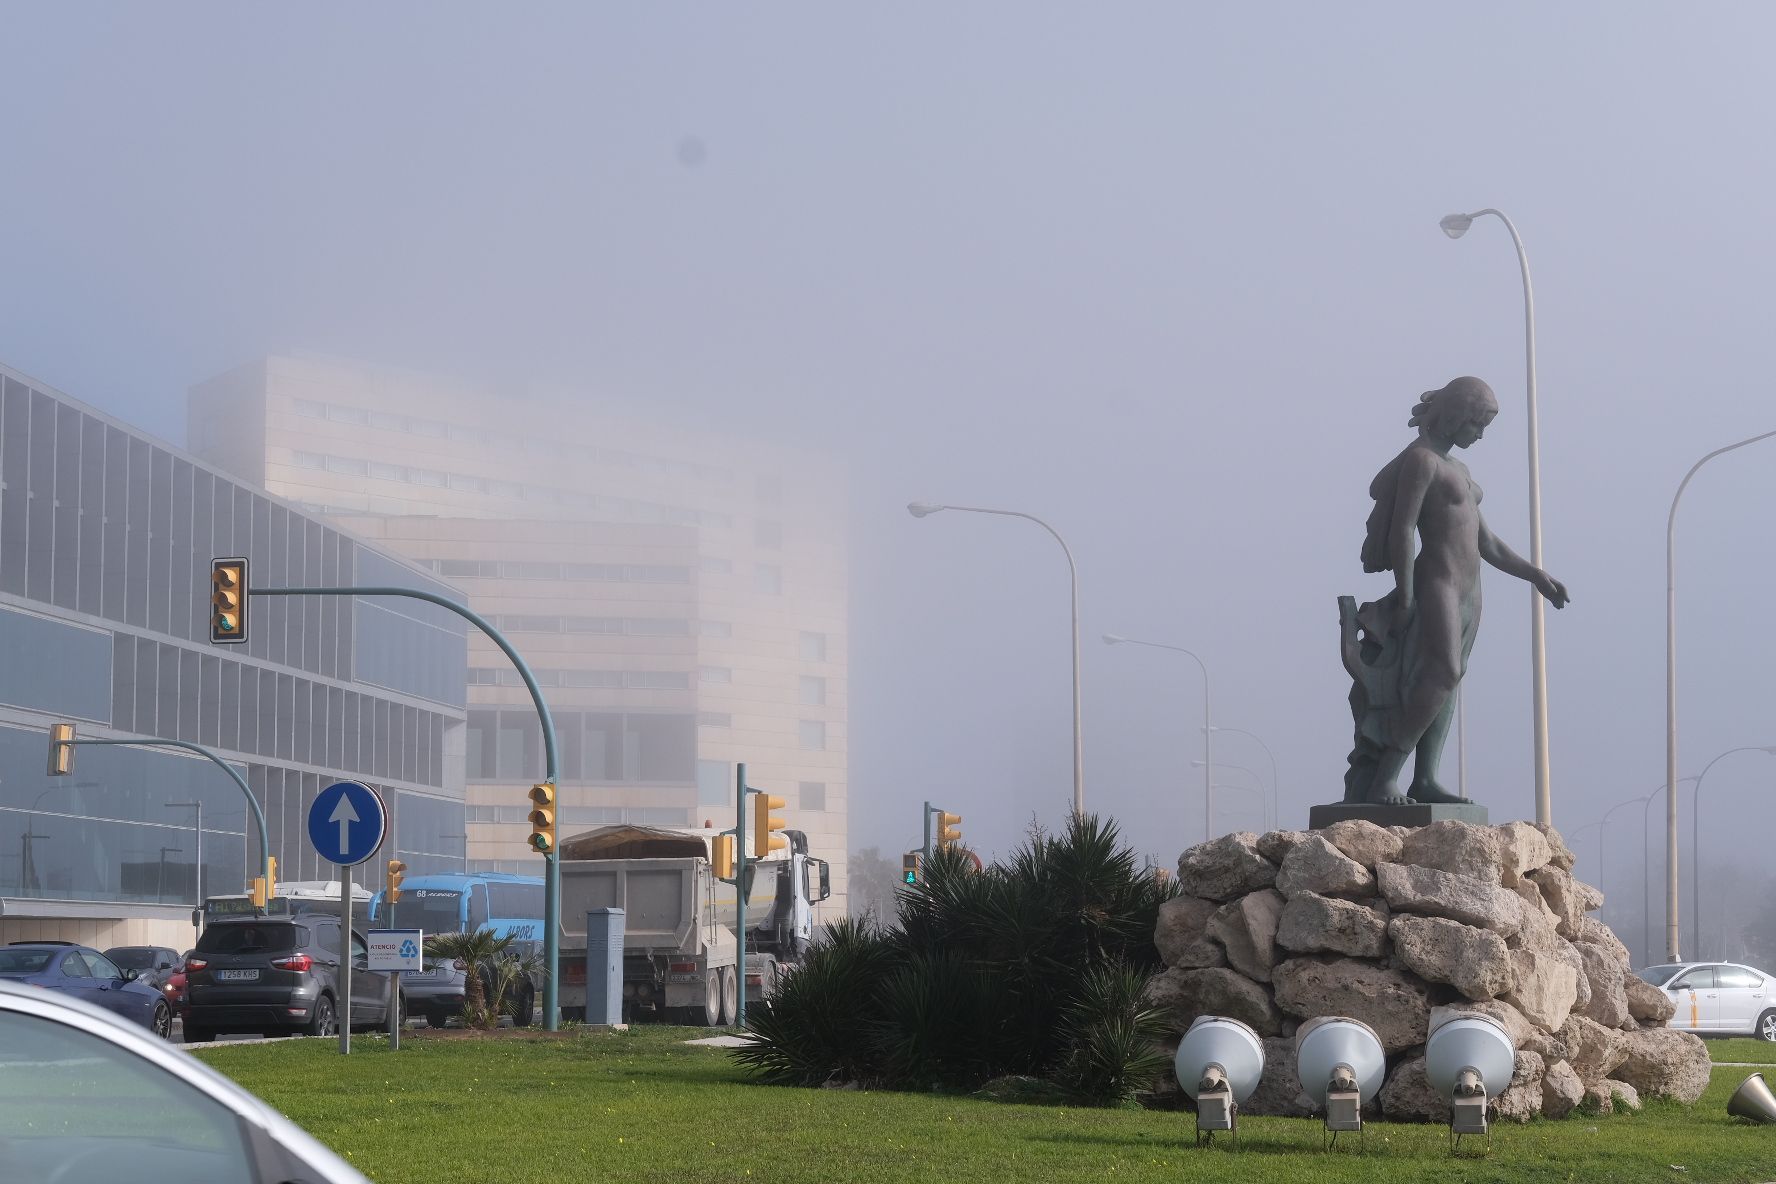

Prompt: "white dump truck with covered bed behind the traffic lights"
[556,825,833,1026]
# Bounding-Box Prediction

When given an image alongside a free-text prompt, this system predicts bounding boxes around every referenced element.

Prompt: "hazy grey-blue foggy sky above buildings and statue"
[0,2,1776,944]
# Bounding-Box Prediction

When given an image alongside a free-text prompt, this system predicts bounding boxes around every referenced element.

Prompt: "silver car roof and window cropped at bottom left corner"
[0,979,369,1184]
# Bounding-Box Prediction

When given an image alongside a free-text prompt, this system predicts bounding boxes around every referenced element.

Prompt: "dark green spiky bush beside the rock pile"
[735,815,1176,1102]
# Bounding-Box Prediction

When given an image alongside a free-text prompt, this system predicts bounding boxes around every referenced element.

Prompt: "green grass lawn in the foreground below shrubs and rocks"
[197,1028,1776,1184]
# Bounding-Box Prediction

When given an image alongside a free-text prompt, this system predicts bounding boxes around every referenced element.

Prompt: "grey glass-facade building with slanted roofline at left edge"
[0,367,467,948]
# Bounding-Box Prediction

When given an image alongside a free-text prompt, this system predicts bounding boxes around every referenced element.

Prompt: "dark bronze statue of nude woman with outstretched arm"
[1339,378,1566,806]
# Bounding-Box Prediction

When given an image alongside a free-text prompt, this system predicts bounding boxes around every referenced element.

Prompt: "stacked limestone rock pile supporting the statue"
[1149,822,1709,1122]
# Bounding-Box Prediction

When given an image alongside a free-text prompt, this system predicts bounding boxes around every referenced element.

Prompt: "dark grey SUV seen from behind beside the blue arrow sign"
[185,912,401,1042]
